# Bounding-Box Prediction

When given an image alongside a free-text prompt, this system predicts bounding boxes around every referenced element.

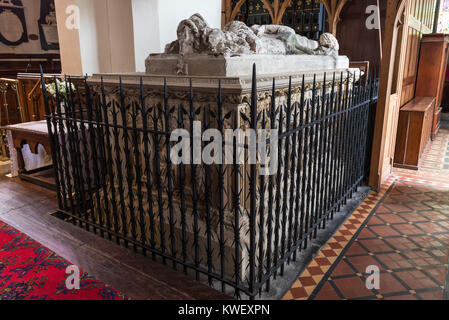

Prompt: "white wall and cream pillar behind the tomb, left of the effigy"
[56,0,221,74]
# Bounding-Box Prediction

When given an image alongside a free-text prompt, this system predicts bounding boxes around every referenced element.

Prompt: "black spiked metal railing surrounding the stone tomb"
[43,70,378,298]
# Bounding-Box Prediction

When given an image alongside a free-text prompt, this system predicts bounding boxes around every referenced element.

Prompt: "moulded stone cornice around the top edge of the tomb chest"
[88,68,362,105]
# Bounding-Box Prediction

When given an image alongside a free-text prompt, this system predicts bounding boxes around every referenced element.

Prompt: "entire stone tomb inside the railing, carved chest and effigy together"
[81,14,360,286]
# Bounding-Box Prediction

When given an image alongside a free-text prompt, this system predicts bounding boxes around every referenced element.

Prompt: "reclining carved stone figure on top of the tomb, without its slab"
[165,14,339,56]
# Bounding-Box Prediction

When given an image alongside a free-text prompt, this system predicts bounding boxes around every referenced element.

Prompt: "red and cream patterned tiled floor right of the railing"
[284,130,449,300]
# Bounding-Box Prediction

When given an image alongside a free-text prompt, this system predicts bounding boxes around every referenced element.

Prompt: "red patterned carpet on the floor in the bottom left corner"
[0,221,126,300]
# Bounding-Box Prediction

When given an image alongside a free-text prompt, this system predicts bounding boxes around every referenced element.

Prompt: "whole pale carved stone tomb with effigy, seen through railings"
[89,14,360,279]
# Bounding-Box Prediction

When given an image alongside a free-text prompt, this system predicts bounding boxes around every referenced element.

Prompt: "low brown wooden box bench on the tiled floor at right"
[394,97,435,170]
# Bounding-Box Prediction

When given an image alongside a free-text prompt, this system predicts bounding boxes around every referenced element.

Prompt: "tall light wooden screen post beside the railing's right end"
[370,0,436,189]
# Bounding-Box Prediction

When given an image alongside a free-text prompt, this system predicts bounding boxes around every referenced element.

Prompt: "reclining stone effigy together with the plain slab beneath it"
[146,14,349,77]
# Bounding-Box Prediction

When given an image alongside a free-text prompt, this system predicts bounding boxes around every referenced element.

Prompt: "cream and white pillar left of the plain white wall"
[55,0,136,75]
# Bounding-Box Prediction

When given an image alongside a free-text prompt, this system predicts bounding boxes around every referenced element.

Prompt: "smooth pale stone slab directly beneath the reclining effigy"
[146,54,349,77]
